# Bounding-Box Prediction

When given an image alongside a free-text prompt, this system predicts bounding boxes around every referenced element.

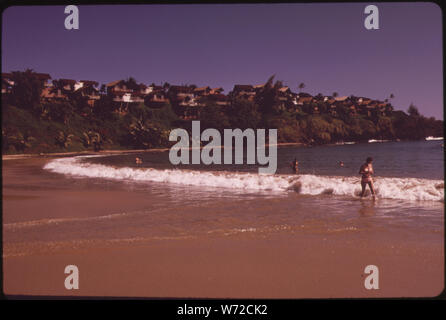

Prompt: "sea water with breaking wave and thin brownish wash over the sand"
[4,141,444,254]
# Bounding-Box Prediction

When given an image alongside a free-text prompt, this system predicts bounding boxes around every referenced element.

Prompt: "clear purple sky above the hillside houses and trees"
[2,3,443,119]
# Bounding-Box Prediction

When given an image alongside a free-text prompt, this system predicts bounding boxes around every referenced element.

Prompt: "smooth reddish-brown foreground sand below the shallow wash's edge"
[4,232,443,298]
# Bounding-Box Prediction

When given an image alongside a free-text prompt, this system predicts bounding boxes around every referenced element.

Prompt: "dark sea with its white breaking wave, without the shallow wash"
[45,141,444,202]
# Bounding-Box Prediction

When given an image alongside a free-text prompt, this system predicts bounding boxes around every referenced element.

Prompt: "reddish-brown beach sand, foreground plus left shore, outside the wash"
[3,158,444,298]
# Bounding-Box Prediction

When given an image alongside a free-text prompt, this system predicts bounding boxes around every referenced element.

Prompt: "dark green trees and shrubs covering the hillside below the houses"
[2,70,443,154]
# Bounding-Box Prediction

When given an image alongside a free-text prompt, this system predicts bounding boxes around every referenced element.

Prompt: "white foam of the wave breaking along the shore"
[44,156,444,201]
